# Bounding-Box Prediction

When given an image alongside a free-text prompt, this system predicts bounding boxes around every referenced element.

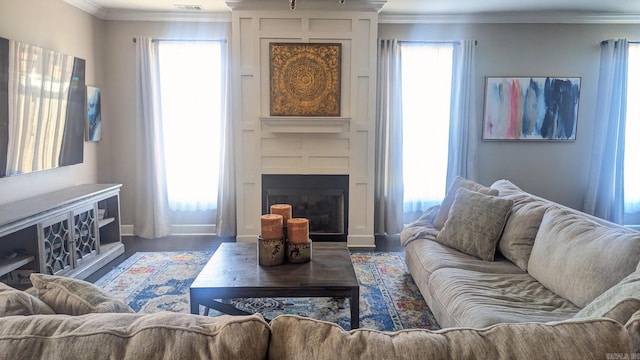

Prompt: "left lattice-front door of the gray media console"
[38,215,73,275]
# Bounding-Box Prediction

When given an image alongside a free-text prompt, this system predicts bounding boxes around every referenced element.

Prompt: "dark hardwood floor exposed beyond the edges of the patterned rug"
[86,235,404,282]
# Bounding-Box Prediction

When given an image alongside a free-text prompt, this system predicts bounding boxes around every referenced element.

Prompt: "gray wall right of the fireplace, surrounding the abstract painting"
[378,24,640,209]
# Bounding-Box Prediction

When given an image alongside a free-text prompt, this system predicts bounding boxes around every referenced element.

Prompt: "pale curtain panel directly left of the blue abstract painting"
[447,40,480,188]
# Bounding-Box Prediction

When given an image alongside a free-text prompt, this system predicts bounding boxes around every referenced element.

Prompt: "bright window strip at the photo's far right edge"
[624,44,640,213]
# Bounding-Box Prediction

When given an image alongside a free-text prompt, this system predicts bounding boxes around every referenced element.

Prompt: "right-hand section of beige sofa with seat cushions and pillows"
[400,178,640,342]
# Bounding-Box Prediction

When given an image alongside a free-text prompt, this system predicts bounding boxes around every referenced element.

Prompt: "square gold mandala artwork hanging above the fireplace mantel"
[269,43,342,116]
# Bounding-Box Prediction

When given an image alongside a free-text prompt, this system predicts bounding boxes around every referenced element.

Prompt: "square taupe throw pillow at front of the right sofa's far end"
[436,188,513,261]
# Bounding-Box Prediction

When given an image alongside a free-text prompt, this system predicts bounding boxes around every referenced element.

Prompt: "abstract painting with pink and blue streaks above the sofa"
[482,76,581,140]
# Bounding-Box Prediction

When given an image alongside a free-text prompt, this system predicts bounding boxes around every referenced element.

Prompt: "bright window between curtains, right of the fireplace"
[401,43,453,213]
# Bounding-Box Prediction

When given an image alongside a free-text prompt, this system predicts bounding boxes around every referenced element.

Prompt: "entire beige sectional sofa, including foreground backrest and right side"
[0,178,640,360]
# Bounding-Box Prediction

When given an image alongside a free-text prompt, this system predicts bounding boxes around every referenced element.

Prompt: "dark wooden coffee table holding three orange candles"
[189,242,360,329]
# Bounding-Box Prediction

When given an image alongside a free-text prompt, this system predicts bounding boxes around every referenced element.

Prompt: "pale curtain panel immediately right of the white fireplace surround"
[374,39,403,234]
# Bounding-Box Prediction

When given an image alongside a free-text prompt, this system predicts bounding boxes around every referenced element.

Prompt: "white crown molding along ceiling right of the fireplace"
[378,13,640,24]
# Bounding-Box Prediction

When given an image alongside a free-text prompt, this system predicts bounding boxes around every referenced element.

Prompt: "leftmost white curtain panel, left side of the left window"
[134,36,171,239]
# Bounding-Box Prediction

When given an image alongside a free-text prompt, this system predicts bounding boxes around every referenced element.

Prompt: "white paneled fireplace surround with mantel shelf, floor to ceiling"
[231,0,384,247]
